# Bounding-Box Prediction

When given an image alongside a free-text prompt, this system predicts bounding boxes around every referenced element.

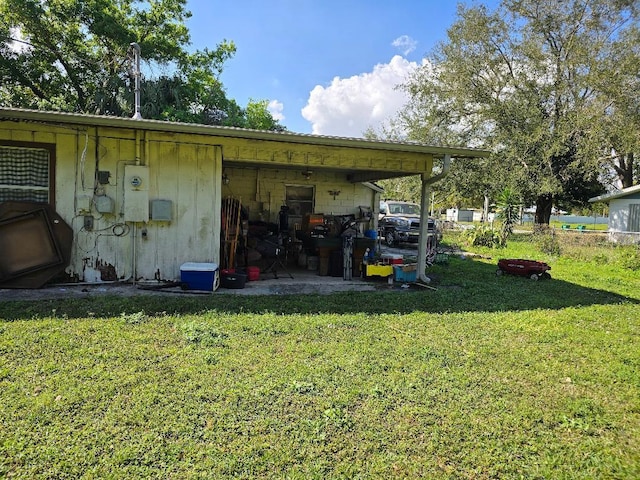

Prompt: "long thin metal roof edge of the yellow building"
[0,108,491,158]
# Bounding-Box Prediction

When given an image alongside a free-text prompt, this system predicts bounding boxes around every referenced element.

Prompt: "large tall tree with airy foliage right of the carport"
[399,0,637,223]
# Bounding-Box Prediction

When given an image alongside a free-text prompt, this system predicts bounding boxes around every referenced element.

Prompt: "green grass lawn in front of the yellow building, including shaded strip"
[0,234,640,479]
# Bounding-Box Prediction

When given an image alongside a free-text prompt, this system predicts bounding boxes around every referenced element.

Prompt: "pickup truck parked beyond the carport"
[378,200,442,247]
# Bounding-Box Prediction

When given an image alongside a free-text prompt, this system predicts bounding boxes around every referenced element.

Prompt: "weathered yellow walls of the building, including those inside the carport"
[0,121,384,282]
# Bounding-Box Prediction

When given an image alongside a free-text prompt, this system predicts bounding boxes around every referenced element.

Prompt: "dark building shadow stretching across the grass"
[0,259,640,321]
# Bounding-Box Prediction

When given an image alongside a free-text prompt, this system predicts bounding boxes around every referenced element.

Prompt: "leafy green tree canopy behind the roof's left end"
[0,0,284,130]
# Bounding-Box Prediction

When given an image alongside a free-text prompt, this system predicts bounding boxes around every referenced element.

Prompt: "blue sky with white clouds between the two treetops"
[187,0,497,137]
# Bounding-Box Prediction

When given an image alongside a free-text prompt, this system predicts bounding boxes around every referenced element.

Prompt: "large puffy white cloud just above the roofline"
[302,55,418,137]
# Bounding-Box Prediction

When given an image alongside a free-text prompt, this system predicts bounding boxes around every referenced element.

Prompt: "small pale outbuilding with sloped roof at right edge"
[589,185,640,243]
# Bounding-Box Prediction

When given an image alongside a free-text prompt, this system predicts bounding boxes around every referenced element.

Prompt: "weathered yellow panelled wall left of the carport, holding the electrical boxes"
[0,123,222,282]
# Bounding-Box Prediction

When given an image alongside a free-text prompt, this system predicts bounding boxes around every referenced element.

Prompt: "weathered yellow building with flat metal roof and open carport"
[0,109,488,282]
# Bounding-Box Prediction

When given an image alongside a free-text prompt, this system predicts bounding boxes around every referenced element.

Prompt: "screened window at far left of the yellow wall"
[0,144,53,203]
